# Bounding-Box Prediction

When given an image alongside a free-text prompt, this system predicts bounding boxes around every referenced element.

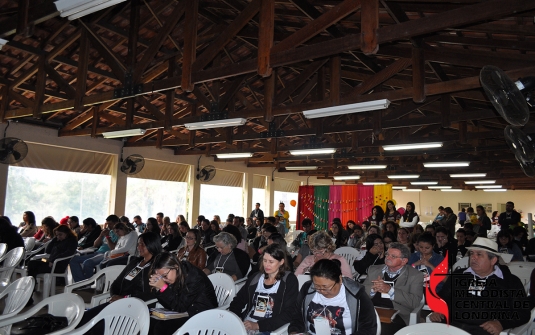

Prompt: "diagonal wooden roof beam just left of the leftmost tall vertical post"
[133,0,186,83]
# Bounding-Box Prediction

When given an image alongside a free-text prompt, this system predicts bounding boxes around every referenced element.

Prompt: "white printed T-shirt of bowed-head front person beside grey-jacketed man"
[307,284,353,335]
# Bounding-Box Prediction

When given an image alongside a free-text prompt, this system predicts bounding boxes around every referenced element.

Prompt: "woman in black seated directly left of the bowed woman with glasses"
[76,232,161,335]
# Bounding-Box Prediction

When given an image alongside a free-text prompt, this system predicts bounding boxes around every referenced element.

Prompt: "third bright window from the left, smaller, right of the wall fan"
[200,184,244,222]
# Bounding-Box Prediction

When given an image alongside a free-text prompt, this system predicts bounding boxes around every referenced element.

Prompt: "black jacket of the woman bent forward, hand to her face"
[156,262,217,317]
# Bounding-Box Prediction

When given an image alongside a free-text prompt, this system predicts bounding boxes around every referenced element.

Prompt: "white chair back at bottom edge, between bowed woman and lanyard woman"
[173,309,247,335]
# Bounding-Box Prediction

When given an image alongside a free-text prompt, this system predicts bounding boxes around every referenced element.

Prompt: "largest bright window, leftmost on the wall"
[4,166,111,225]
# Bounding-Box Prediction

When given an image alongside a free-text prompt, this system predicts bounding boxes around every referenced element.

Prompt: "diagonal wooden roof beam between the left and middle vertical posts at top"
[193,0,260,71]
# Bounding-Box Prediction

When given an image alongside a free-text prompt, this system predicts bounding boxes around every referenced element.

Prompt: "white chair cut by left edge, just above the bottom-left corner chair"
[0,277,35,334]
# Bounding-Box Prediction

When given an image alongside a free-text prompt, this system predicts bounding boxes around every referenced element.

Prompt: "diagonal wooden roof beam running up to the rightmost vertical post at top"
[271,0,360,53]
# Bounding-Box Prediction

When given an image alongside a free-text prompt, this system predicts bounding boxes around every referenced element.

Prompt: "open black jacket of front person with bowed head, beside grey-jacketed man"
[288,278,377,335]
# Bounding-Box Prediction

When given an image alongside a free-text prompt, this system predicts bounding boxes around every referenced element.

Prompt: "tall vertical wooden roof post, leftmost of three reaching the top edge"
[181,0,199,92]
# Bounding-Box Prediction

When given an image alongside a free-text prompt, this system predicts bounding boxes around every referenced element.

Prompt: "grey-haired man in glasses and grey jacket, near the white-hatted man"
[364,242,424,334]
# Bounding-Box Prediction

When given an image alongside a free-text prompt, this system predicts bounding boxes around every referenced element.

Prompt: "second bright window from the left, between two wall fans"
[125,178,191,222]
